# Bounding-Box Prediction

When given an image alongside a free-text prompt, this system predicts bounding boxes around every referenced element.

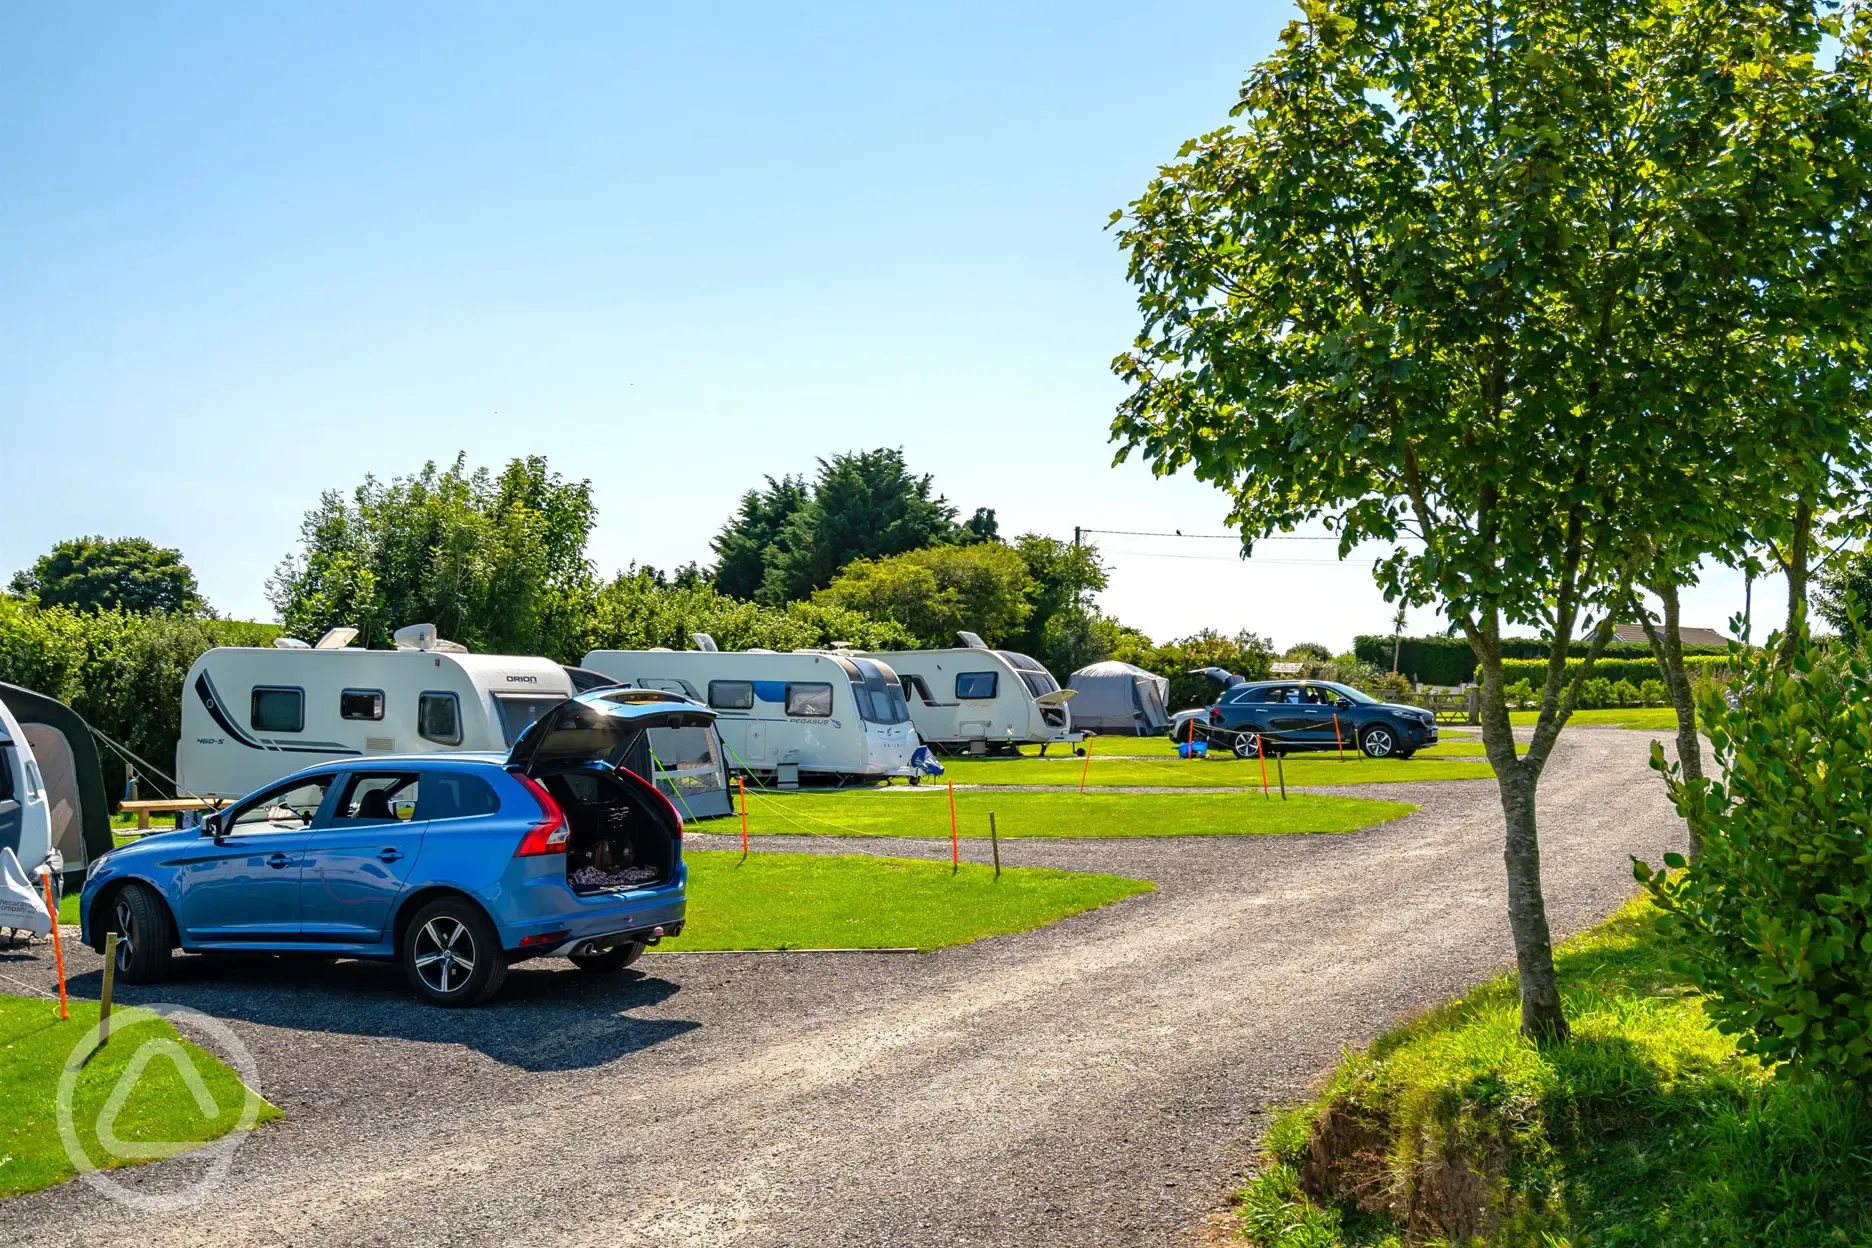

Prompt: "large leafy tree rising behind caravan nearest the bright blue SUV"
[268,455,595,660]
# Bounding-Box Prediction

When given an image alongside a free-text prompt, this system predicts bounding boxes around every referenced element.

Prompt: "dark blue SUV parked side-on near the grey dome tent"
[1207,681,1436,758]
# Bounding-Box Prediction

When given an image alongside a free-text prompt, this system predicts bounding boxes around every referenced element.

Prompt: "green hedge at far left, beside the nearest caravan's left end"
[0,595,279,799]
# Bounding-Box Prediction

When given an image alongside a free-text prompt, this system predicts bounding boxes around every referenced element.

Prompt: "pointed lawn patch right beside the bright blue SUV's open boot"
[661,849,1157,949]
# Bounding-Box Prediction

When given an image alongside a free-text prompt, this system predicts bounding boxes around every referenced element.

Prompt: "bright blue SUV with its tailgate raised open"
[80,689,715,1005]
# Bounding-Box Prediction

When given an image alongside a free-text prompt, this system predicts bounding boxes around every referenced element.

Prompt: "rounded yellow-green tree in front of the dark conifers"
[812,541,1033,649]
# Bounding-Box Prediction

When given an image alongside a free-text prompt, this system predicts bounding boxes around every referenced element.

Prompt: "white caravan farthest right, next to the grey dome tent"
[867,632,1086,754]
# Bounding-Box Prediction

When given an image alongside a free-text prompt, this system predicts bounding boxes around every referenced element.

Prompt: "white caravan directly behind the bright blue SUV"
[176,625,573,797]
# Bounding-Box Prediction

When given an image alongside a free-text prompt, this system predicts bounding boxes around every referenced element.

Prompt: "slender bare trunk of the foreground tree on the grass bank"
[1479,631,1567,1042]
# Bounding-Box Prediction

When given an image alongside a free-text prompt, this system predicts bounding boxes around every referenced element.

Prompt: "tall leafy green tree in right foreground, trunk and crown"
[1114,0,1857,1038]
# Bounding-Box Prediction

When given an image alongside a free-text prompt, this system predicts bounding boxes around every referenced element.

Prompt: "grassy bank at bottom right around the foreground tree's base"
[1237,900,1872,1248]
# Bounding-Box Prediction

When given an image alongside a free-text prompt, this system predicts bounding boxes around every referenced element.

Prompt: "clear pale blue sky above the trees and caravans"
[0,0,1767,646]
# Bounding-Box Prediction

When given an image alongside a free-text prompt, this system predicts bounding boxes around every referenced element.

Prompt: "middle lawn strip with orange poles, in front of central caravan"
[737,784,1415,838]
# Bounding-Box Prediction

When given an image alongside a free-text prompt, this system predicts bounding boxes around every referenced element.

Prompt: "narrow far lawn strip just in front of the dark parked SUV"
[943,750,1494,790]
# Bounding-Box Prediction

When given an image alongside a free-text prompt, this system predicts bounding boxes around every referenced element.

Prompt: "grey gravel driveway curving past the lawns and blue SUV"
[0,728,1681,1248]
